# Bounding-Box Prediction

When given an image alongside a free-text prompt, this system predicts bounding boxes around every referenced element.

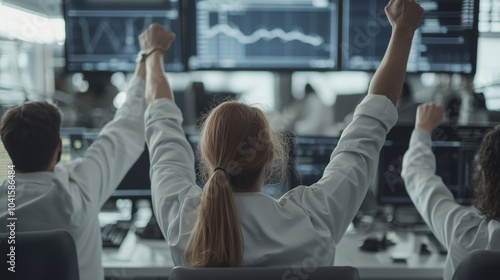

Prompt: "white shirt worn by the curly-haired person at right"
[402,129,500,280]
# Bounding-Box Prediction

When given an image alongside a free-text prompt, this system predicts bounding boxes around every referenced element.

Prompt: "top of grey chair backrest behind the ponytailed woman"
[168,266,359,280]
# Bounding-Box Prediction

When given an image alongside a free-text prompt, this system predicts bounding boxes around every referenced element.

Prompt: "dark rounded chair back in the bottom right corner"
[452,250,500,280]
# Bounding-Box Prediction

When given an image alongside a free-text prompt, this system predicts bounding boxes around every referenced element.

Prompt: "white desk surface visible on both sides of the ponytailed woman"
[102,232,446,280]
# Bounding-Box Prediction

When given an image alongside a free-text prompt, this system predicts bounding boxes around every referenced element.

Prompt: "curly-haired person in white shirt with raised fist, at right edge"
[402,103,500,280]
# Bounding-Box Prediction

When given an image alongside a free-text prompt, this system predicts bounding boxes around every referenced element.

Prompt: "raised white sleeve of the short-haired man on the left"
[69,77,146,209]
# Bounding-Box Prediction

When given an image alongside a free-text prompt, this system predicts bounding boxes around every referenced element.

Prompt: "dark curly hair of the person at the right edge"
[473,126,500,221]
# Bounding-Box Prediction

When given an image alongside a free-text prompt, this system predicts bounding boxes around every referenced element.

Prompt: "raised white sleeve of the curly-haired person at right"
[401,129,474,248]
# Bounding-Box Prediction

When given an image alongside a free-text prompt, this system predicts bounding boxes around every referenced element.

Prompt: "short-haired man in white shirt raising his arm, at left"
[0,55,146,280]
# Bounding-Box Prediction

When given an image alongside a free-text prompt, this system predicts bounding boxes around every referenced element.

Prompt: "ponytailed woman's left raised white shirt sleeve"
[145,98,201,236]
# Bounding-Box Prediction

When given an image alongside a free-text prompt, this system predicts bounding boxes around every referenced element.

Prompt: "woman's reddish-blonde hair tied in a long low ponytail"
[185,101,287,267]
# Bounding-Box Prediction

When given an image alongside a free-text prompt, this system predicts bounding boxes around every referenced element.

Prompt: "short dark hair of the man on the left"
[0,102,62,172]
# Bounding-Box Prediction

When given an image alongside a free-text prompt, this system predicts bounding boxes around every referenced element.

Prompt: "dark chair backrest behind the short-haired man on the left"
[0,229,80,280]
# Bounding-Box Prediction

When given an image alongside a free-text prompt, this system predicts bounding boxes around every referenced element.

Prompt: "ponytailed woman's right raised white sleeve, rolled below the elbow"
[280,94,397,244]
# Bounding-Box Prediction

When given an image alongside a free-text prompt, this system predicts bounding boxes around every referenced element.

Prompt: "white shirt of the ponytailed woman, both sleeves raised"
[145,95,397,266]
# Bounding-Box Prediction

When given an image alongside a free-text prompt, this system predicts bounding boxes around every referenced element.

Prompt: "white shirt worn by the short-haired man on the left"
[0,78,146,280]
